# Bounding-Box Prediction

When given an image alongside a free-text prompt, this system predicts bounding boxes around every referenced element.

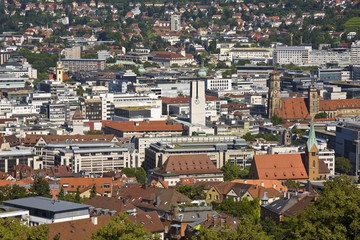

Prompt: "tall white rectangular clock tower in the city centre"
[190,80,205,126]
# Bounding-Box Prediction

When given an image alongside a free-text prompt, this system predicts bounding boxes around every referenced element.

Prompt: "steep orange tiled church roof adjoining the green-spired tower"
[251,153,308,180]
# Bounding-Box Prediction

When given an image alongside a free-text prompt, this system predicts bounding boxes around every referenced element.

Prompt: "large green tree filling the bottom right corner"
[287,175,360,239]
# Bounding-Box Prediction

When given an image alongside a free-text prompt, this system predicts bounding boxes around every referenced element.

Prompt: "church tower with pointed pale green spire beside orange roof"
[304,118,320,181]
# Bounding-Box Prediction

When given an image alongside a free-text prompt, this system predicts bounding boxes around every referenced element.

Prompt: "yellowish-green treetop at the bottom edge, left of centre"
[91,213,160,240]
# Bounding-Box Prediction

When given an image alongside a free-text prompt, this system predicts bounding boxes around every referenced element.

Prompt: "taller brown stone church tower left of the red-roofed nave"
[268,70,281,118]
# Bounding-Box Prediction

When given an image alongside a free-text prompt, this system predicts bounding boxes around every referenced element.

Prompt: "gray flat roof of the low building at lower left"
[3,197,90,212]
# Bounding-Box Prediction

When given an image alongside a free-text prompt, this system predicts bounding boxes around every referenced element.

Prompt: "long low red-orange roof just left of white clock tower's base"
[105,120,183,132]
